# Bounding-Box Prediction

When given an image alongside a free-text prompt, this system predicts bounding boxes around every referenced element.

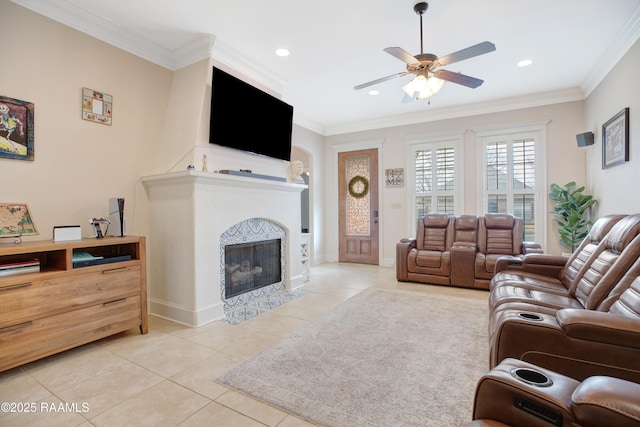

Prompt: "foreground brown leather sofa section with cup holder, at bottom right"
[466,359,640,427]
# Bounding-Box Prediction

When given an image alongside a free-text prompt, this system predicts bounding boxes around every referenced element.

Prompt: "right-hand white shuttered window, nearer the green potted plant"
[482,132,543,241]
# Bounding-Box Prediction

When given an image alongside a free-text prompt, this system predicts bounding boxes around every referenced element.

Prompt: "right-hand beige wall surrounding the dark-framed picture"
[584,37,640,216]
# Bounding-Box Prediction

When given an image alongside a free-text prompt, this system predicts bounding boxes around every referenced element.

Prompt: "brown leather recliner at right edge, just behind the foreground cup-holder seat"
[489,254,640,383]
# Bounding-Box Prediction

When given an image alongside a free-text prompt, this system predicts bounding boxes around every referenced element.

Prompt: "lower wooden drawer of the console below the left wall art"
[0,296,141,371]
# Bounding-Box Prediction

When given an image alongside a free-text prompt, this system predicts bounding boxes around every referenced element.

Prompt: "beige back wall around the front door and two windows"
[325,102,586,265]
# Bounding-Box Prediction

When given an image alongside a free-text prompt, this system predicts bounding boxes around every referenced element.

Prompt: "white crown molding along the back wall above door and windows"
[325,87,584,136]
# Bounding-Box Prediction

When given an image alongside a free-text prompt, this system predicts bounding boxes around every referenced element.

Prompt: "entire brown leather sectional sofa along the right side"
[466,214,640,427]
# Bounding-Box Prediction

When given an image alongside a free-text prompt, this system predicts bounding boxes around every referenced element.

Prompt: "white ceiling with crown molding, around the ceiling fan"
[13,0,640,135]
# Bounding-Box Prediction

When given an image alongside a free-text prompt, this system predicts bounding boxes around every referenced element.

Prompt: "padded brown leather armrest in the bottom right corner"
[571,376,640,426]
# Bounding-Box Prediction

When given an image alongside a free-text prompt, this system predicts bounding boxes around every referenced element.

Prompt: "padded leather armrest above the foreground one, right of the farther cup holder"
[556,308,640,349]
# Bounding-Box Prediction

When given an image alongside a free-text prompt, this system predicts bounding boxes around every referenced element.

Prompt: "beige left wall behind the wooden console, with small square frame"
[0,0,172,240]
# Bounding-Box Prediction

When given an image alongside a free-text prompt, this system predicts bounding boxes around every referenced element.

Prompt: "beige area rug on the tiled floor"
[218,289,489,427]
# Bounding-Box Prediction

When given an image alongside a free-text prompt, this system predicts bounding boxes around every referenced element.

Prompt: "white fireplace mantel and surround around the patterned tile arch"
[142,171,307,326]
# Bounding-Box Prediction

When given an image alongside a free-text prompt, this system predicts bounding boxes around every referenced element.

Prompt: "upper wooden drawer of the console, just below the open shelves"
[0,265,141,328]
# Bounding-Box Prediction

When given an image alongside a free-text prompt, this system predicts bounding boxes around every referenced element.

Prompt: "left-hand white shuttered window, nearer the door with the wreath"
[411,141,461,224]
